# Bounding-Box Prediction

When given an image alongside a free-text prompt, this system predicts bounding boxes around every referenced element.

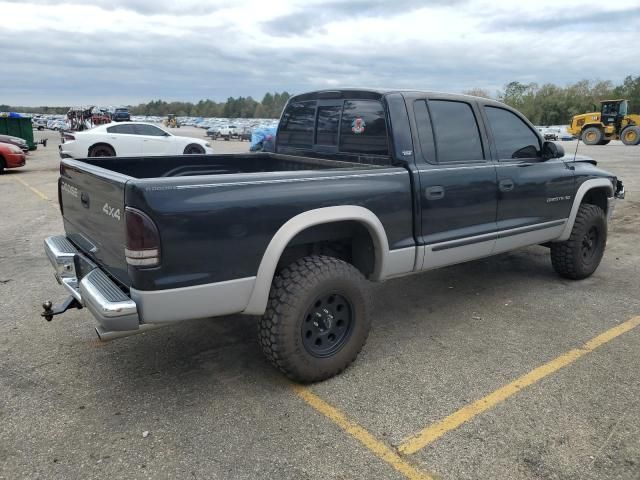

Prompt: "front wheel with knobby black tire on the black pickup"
[551,203,607,280]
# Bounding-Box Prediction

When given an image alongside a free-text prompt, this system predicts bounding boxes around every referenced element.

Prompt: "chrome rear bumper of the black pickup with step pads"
[44,235,140,333]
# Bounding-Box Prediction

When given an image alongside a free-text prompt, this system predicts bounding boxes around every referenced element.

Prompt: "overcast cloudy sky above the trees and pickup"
[0,0,640,106]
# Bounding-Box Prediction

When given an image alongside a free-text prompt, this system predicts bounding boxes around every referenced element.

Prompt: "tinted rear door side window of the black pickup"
[429,100,484,163]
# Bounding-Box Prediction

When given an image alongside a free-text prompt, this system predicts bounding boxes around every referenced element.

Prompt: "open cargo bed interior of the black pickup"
[83,153,389,179]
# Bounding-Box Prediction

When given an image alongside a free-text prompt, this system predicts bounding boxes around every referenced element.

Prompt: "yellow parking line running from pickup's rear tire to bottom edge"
[293,385,433,480]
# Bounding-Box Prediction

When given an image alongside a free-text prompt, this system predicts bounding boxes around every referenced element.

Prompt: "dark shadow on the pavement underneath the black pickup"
[96,247,563,388]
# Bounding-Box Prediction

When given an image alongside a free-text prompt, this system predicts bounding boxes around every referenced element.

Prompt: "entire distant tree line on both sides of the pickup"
[5,75,640,125]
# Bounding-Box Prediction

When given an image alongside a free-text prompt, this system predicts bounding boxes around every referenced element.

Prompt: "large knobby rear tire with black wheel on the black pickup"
[258,255,371,383]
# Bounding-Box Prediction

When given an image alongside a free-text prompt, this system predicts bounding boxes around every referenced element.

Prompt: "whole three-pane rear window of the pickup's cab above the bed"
[278,100,389,155]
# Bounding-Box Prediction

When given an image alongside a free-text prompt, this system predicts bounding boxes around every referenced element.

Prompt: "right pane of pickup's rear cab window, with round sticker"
[340,100,389,155]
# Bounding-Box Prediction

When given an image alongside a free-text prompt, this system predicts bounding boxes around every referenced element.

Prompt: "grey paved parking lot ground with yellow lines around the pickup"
[0,128,640,480]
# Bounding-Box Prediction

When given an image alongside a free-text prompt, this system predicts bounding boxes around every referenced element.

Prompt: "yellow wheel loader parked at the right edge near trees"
[567,99,640,145]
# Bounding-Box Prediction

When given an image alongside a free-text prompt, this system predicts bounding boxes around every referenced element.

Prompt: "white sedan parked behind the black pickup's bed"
[60,122,213,158]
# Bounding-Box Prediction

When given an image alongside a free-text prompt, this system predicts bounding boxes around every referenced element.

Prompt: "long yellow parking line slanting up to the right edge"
[398,317,640,455]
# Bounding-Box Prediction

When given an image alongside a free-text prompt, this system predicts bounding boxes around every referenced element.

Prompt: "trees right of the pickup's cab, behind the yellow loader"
[464,75,640,125]
